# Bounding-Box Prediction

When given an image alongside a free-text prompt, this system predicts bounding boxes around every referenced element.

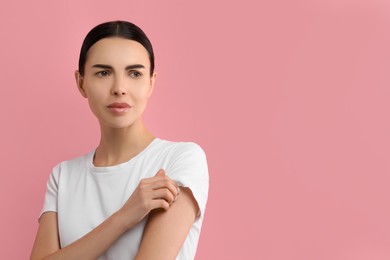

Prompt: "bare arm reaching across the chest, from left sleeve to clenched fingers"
[30,170,178,260]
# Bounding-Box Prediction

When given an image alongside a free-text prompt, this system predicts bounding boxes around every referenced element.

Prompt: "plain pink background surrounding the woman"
[0,0,390,260]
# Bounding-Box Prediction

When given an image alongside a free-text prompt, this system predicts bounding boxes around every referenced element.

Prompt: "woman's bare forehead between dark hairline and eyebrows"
[86,37,150,67]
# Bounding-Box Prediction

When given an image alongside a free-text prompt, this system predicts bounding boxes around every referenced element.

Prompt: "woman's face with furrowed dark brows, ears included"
[76,38,156,128]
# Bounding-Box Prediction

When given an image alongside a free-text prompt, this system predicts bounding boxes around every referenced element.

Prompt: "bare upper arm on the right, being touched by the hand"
[136,188,199,259]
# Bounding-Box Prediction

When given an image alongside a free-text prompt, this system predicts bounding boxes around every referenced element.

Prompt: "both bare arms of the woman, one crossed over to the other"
[30,171,199,260]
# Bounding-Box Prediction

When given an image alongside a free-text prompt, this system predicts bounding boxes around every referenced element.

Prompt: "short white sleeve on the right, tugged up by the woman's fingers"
[167,142,209,217]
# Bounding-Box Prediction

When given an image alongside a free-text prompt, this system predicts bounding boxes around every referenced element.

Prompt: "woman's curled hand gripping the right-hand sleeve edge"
[117,169,179,229]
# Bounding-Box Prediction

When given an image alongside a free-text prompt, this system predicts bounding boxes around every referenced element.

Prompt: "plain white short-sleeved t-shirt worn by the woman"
[42,138,209,260]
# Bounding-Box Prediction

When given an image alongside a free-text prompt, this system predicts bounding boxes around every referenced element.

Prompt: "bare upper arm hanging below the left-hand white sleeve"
[30,211,60,260]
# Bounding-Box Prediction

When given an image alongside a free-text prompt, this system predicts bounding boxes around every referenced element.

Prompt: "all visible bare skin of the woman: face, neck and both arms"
[30,38,199,260]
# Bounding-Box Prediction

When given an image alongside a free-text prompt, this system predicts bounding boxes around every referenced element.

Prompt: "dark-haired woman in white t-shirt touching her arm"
[31,21,208,260]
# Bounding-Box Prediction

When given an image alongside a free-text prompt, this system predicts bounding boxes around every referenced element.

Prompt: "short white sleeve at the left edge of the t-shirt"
[39,165,60,217]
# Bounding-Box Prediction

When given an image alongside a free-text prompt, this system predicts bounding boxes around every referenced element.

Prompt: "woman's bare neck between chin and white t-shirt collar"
[94,121,154,166]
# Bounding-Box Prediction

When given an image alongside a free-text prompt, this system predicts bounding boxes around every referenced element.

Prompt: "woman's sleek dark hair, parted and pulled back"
[79,21,154,75]
